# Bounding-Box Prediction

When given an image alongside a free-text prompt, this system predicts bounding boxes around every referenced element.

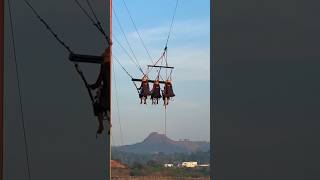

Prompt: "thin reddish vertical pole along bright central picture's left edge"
[107,0,112,180]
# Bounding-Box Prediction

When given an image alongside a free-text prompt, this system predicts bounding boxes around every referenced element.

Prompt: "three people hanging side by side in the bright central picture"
[138,75,175,106]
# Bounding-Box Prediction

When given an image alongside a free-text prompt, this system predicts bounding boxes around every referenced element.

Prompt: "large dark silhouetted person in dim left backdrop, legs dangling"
[90,41,112,134]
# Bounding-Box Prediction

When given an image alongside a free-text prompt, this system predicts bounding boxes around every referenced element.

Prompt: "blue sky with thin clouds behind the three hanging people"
[112,0,210,145]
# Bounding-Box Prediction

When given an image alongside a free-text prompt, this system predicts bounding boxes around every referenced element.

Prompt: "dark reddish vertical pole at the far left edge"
[0,0,4,180]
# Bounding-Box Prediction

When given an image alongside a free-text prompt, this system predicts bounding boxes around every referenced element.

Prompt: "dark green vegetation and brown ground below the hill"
[112,151,210,177]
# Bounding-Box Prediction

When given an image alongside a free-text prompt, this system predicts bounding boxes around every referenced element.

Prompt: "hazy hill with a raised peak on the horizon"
[112,132,210,154]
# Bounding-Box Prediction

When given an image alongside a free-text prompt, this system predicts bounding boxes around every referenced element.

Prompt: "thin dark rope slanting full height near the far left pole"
[8,0,31,180]
